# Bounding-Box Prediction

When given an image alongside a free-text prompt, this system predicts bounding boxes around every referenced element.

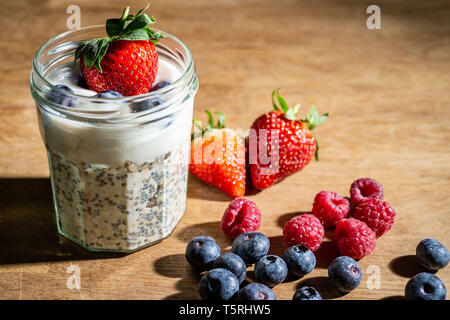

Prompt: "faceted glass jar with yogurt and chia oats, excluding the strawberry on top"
[30,26,198,252]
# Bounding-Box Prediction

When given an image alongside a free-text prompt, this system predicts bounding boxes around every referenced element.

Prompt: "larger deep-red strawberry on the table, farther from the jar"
[248,89,328,190]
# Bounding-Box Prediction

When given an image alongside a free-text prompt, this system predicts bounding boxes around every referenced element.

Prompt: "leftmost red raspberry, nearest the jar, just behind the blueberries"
[221,198,261,239]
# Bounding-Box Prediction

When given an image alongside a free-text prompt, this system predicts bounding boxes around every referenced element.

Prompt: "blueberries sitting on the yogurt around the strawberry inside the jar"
[47,79,171,112]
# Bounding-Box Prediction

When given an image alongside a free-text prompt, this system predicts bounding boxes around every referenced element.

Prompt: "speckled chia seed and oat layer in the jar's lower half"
[48,141,189,251]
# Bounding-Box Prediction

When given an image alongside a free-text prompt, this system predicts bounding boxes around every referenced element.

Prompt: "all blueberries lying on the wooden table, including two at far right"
[186,232,450,300]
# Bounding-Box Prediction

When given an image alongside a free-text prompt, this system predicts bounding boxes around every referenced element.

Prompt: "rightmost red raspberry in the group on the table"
[354,199,395,237]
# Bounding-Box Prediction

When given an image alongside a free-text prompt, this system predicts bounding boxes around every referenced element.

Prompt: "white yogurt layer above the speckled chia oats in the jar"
[42,60,193,167]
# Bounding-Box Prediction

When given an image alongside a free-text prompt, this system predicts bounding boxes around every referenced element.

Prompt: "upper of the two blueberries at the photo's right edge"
[416,239,450,270]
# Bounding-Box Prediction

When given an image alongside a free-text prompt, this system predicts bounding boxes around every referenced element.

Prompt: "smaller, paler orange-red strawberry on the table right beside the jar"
[189,110,245,197]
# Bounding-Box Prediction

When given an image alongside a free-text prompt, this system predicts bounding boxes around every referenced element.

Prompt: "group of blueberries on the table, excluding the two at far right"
[186,232,362,300]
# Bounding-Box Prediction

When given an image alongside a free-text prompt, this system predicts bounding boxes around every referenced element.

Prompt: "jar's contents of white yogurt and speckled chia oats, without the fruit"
[38,60,194,252]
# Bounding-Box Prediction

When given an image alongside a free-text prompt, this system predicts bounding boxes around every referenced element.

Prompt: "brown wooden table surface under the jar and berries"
[0,0,450,299]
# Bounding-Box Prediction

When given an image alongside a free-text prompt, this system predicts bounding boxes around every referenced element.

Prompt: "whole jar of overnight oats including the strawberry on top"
[31,8,198,252]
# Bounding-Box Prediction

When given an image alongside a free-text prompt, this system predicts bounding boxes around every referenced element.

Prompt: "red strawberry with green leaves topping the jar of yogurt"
[75,6,162,96]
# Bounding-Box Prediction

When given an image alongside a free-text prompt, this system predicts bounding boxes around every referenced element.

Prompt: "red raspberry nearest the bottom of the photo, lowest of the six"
[334,218,377,259]
